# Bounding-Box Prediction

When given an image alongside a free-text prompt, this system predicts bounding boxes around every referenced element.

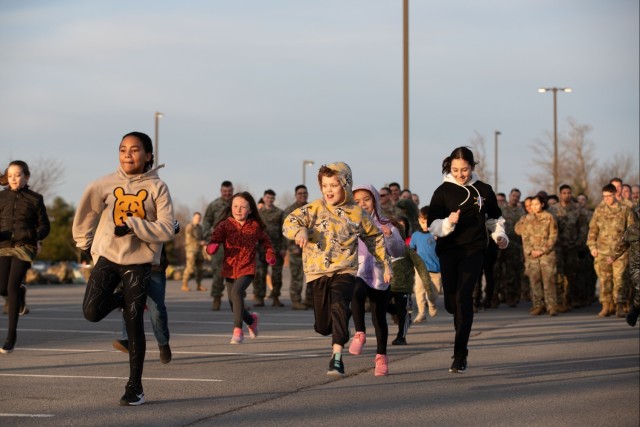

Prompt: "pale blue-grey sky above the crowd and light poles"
[0,0,640,209]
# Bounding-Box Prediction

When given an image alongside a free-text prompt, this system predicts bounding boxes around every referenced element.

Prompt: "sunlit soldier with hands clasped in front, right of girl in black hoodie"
[515,195,558,316]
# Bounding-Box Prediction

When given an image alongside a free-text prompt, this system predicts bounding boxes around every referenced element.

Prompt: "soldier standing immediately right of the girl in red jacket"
[253,189,287,307]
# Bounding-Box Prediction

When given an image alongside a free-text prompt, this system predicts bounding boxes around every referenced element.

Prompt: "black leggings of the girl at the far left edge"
[0,256,31,342]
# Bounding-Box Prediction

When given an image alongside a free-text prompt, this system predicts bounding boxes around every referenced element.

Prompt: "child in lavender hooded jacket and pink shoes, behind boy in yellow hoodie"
[349,185,405,376]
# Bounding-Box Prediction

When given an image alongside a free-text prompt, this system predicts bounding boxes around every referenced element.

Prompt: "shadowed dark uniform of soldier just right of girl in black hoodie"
[491,205,525,307]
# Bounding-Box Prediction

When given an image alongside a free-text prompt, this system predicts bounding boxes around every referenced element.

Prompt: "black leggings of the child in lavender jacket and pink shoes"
[351,277,391,354]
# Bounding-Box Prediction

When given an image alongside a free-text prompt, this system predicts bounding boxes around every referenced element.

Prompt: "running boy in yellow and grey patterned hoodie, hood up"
[283,162,393,377]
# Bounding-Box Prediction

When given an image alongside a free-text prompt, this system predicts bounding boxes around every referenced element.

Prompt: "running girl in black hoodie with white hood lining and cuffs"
[428,147,509,373]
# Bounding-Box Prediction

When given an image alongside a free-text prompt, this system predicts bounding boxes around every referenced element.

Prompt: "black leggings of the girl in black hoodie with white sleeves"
[440,249,485,354]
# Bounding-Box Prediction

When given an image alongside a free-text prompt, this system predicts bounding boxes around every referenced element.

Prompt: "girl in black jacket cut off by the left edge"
[0,160,49,353]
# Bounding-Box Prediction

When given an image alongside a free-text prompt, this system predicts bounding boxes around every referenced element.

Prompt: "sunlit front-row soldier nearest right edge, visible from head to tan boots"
[587,184,635,317]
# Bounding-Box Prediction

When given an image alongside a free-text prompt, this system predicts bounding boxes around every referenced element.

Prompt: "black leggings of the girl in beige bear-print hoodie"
[82,257,151,384]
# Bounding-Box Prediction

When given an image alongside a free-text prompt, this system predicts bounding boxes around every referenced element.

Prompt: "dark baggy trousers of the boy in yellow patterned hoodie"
[310,274,356,346]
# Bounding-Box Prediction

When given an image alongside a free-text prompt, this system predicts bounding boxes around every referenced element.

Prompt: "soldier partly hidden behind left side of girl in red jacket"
[202,181,233,311]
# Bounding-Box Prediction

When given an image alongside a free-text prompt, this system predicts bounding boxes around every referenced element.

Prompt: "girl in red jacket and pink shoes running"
[207,191,276,344]
